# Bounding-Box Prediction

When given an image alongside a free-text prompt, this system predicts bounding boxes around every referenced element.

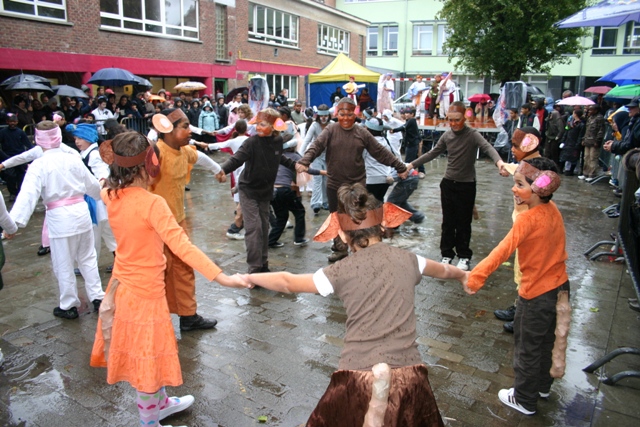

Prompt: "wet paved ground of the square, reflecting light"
[0,153,640,427]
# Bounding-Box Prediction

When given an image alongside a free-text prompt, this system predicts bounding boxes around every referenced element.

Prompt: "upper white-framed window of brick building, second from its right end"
[248,2,300,49]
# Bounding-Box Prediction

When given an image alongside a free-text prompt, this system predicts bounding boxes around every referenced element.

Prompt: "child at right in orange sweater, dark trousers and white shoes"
[465,157,569,415]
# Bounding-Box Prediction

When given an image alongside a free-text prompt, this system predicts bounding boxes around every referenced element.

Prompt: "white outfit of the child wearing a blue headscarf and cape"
[80,144,117,259]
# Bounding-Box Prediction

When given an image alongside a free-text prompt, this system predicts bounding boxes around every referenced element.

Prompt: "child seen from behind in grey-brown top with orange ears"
[247,184,467,427]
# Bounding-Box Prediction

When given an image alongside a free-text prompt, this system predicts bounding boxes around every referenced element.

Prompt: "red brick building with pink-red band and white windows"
[0,0,369,103]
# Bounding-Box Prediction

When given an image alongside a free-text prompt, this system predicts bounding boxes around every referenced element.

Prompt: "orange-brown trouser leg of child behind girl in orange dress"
[164,221,198,316]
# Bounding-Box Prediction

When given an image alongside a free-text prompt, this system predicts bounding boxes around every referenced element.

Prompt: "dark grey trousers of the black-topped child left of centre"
[239,191,269,273]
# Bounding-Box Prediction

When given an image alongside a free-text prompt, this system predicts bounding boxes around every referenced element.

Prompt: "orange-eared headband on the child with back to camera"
[313,202,412,242]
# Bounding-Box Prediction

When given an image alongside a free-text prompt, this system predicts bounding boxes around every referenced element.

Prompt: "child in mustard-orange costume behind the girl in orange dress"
[149,108,225,331]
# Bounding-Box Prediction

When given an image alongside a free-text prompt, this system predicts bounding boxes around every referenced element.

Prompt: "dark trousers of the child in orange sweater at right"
[513,281,569,411]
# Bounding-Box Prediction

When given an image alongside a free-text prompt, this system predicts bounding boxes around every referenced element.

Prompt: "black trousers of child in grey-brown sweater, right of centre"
[440,178,476,259]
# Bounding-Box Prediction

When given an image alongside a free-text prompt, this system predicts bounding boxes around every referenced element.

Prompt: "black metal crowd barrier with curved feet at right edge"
[583,149,640,385]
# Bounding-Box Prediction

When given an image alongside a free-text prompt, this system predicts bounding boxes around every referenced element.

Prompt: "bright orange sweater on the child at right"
[468,202,568,300]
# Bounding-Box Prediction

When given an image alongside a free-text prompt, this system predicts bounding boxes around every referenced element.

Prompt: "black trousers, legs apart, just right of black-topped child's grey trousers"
[269,187,306,245]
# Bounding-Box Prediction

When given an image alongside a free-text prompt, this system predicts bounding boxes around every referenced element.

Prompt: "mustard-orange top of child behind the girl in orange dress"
[149,139,198,222]
